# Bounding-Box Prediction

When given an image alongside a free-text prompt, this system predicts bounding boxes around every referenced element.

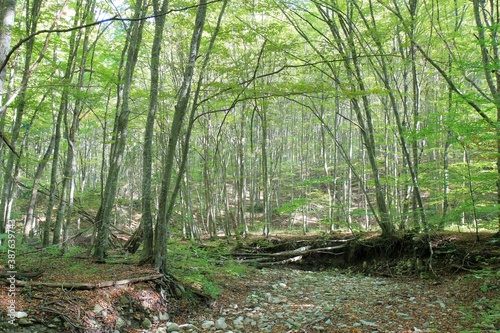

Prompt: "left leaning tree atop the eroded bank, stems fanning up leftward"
[287,1,394,236]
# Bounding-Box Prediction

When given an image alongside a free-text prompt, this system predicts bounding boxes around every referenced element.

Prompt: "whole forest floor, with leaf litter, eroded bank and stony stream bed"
[0,233,500,333]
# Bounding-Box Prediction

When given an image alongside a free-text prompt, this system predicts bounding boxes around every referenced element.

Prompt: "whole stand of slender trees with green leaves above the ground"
[0,0,500,332]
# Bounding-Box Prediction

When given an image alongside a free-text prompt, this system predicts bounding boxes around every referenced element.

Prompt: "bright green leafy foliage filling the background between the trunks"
[0,0,498,249]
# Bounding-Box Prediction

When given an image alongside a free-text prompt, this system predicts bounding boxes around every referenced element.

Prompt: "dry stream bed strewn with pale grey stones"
[0,268,500,333]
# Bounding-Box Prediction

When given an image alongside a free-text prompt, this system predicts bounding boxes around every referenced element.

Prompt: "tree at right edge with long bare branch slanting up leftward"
[406,0,500,228]
